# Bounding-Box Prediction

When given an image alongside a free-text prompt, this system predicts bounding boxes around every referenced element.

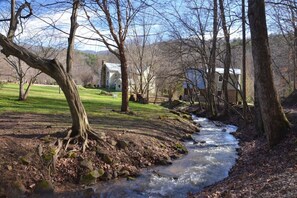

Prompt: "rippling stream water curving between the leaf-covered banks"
[94,116,239,198]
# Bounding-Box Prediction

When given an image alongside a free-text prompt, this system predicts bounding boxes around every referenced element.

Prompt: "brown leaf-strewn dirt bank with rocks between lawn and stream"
[0,113,197,197]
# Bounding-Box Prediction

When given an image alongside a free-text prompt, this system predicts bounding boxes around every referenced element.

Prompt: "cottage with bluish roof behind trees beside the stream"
[183,68,241,103]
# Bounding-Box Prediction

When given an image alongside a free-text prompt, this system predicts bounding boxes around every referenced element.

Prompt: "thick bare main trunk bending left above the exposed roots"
[0,34,104,138]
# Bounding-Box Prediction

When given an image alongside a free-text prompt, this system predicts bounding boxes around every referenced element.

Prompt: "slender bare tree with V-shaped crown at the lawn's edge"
[84,0,145,112]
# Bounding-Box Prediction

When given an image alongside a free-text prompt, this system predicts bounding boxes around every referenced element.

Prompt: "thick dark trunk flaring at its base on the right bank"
[248,0,289,147]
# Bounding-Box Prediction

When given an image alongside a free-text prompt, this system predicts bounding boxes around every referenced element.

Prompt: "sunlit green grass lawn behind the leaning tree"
[0,84,172,120]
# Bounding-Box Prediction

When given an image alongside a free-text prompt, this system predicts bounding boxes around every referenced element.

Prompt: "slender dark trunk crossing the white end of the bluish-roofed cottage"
[219,0,231,115]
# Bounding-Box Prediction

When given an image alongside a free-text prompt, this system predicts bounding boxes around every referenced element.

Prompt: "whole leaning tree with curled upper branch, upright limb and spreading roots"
[0,0,104,150]
